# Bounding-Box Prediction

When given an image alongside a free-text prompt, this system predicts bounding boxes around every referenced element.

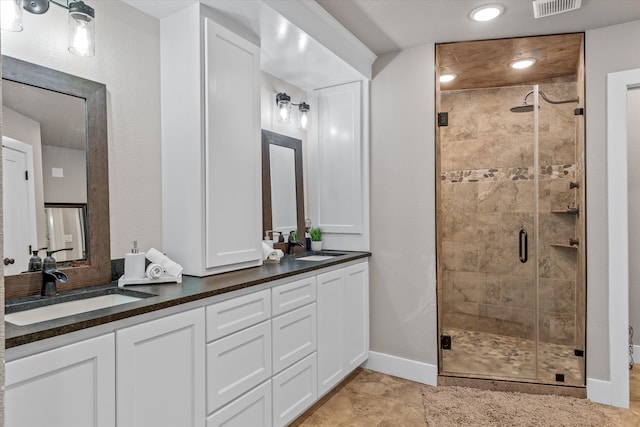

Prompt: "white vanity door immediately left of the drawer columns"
[116,308,205,427]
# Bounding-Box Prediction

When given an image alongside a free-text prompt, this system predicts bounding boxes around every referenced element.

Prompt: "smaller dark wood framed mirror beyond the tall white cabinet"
[262,129,305,243]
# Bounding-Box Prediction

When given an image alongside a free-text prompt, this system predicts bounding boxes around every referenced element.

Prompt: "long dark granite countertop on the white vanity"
[5,251,371,348]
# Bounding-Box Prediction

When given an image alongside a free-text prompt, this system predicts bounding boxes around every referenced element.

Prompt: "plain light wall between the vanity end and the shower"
[370,45,438,366]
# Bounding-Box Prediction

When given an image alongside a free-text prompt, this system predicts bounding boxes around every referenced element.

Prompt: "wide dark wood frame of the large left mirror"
[2,56,111,299]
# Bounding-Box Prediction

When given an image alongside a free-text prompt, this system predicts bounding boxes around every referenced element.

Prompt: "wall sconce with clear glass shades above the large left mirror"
[0,0,96,56]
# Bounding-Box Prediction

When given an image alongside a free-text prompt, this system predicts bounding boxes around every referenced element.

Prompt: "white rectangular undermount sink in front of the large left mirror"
[4,287,155,326]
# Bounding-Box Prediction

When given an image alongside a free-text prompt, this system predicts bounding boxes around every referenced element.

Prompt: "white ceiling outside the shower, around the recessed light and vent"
[317,0,640,55]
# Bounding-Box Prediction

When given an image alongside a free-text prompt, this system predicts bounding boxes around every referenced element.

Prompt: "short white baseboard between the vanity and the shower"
[362,351,438,386]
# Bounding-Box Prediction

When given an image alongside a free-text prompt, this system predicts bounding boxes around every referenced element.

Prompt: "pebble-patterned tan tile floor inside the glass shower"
[442,328,584,386]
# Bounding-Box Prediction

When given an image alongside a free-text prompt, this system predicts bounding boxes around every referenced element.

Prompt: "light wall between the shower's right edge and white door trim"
[585,21,640,381]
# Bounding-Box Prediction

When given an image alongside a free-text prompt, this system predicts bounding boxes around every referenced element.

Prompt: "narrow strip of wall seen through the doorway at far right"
[627,89,640,344]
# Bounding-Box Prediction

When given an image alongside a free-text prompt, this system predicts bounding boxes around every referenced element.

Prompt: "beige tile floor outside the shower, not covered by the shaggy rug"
[291,364,640,427]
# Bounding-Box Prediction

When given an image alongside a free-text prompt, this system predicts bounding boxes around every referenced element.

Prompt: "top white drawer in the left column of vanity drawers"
[207,289,271,342]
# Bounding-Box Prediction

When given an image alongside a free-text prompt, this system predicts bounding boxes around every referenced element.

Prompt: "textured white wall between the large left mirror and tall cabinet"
[1,1,162,258]
